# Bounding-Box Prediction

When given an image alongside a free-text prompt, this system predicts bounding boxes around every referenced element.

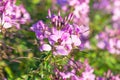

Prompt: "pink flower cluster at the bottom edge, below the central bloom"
[55,60,95,80]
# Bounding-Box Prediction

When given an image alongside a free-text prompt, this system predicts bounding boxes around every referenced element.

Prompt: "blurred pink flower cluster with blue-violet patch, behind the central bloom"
[57,0,89,25]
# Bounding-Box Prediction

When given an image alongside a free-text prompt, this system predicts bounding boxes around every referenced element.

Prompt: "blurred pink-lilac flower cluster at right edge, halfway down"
[96,28,120,54]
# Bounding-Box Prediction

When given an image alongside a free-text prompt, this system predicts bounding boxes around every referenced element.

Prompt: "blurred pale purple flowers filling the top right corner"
[94,0,120,29]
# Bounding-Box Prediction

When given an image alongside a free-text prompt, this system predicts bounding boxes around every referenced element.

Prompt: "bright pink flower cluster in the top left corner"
[0,0,30,32]
